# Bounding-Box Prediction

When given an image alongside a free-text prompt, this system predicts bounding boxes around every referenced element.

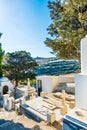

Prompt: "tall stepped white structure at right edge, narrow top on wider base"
[75,36,87,110]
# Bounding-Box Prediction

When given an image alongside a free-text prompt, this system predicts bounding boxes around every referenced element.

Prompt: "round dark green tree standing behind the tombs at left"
[4,51,38,86]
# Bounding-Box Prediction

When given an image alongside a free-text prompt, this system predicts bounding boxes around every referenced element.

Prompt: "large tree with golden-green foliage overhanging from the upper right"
[45,0,87,59]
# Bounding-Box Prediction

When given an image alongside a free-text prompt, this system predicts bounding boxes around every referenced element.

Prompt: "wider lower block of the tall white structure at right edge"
[75,74,87,110]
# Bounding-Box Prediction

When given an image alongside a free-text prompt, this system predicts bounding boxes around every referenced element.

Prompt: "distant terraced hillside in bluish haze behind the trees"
[35,57,80,75]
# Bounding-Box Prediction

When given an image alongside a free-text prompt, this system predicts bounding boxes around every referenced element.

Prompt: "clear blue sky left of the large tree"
[0,0,54,57]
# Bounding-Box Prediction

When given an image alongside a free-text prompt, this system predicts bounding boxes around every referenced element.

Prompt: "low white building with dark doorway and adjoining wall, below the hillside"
[36,74,75,95]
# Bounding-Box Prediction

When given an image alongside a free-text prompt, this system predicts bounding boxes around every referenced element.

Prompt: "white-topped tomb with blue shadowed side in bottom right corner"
[62,107,87,130]
